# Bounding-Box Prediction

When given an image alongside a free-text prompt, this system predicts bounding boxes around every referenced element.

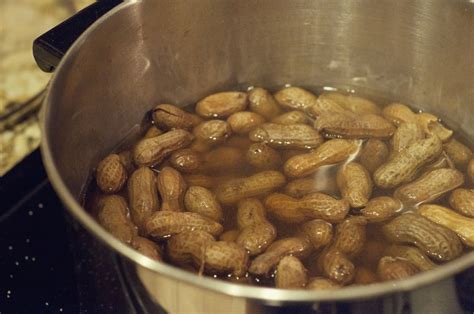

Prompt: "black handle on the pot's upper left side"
[33,0,122,72]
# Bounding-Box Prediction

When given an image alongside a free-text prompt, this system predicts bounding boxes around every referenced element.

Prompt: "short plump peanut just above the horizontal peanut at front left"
[184,186,224,222]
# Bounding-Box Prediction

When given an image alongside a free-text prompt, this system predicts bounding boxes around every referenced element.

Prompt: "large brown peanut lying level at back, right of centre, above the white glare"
[314,112,395,139]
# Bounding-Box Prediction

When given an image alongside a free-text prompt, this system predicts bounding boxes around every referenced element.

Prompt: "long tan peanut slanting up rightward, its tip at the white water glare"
[283,139,359,178]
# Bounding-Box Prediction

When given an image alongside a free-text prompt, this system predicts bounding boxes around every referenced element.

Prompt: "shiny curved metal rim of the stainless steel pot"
[40,0,474,305]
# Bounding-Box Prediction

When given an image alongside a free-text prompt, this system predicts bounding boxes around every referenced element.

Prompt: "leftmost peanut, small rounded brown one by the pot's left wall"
[96,154,128,193]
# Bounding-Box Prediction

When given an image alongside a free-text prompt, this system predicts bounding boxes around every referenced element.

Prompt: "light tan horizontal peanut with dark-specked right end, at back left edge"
[196,92,248,118]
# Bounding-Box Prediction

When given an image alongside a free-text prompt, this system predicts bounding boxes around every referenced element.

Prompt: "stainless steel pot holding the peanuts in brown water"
[34,0,474,312]
